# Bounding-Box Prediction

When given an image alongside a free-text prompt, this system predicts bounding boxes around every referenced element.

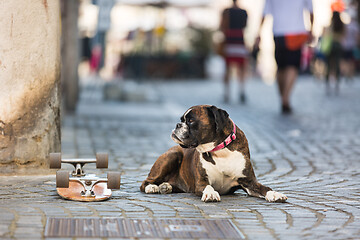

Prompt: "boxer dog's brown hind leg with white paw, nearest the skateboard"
[140,147,183,193]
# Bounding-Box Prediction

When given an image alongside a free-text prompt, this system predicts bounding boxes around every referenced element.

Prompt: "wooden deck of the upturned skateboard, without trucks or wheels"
[56,180,111,202]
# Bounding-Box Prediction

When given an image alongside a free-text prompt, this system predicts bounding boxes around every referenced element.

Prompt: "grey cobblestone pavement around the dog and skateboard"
[0,77,360,239]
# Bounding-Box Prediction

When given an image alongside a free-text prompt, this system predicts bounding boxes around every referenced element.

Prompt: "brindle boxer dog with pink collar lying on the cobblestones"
[140,105,287,202]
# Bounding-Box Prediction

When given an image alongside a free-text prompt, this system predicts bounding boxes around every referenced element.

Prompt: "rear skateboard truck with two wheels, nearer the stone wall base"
[50,153,109,177]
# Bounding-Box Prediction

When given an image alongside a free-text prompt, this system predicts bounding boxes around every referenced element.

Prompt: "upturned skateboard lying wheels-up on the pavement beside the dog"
[50,153,120,202]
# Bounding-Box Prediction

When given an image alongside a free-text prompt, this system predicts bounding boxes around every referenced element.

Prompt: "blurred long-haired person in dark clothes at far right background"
[323,11,345,94]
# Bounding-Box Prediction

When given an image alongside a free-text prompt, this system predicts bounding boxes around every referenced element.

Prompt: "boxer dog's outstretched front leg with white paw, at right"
[238,178,287,202]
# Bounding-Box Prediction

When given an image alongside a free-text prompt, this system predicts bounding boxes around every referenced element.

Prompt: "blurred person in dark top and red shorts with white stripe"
[220,0,248,103]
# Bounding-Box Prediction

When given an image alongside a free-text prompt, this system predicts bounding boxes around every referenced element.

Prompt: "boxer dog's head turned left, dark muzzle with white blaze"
[171,105,231,148]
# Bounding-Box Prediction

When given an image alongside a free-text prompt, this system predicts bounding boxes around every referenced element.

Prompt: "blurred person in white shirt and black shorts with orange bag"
[254,0,314,114]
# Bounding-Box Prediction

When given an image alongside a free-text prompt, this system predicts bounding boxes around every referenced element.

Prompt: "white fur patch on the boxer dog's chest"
[200,149,246,194]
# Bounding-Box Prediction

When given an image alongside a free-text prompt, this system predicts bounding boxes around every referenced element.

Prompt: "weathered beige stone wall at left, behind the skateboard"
[0,0,61,174]
